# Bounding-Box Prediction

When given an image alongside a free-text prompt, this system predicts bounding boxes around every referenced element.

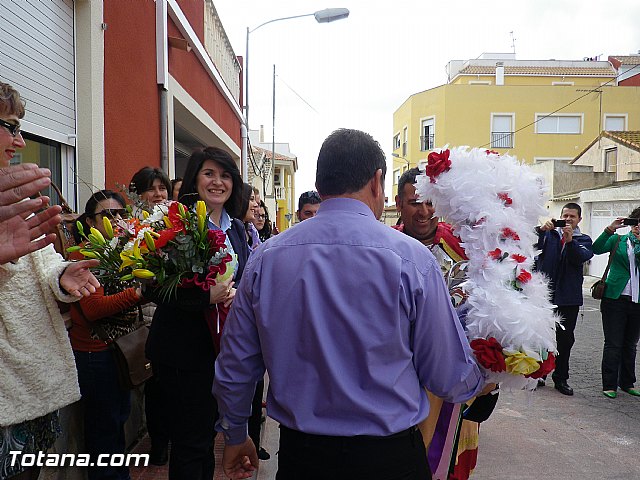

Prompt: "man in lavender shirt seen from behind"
[213,129,493,480]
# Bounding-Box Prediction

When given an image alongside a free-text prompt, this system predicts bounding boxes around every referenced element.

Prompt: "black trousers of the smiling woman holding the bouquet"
[153,364,218,480]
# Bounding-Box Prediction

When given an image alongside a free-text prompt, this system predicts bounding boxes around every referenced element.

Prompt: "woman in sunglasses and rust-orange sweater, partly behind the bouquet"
[69,190,142,480]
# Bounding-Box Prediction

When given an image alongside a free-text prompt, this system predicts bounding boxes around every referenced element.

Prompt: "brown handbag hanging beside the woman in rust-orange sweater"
[92,306,153,390]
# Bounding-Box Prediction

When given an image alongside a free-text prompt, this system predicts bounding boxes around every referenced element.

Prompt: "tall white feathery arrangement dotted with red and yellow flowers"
[416,147,557,389]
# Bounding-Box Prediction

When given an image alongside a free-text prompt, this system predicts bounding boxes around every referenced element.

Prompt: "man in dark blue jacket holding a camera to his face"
[536,203,593,395]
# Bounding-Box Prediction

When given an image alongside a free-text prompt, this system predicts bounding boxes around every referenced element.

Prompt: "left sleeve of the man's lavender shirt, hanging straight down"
[213,260,265,445]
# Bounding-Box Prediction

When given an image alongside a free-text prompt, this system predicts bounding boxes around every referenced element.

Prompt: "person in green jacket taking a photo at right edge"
[593,207,640,398]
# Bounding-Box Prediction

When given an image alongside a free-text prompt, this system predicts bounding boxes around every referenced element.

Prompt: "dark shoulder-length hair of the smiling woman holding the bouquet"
[178,147,243,219]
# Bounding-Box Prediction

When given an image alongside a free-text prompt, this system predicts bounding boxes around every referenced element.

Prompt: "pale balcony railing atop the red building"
[204,0,241,103]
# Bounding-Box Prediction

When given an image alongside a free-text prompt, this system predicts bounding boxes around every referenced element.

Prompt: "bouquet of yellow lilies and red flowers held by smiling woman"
[73,201,234,300]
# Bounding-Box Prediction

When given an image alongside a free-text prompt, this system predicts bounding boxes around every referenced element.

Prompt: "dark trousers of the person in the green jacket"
[600,296,640,391]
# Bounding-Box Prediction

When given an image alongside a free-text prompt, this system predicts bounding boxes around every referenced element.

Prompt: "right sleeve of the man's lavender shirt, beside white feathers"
[412,256,485,403]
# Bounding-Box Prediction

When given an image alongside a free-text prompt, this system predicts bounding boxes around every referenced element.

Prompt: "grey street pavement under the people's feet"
[257,278,640,480]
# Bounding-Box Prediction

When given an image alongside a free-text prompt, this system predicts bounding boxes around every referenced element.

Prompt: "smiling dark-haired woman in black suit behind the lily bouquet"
[147,147,249,480]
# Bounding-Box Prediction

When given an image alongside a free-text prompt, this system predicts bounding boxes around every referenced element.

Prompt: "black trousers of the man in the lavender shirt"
[276,426,431,480]
